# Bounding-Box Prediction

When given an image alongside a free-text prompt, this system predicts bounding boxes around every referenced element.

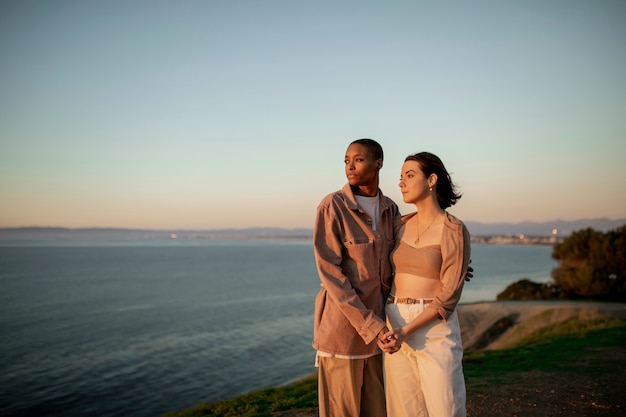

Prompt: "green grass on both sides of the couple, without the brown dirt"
[166,319,626,417]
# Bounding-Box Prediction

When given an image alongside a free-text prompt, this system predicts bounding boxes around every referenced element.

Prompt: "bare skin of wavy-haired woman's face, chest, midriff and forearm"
[378,161,444,353]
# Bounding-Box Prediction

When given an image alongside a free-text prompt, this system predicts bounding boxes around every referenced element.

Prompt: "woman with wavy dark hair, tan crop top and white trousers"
[379,152,470,417]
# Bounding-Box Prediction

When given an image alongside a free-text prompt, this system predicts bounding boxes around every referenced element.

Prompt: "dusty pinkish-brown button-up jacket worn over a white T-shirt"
[313,184,400,356]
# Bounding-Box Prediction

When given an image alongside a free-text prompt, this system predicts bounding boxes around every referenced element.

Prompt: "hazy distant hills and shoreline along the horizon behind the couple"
[0,218,626,240]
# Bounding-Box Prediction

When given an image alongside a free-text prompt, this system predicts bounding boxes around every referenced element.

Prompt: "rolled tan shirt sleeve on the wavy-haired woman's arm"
[428,220,471,321]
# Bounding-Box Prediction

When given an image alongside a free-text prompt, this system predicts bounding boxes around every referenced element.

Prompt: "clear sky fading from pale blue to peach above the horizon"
[0,0,626,229]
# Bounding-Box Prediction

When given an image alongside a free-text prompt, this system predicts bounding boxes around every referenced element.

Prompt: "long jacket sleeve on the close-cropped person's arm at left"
[313,201,385,344]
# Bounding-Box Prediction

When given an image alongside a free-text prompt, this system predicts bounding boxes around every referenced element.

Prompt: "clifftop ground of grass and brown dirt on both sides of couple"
[166,318,626,417]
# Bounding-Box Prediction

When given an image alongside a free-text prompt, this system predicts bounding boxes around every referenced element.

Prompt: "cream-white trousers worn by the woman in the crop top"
[384,304,466,417]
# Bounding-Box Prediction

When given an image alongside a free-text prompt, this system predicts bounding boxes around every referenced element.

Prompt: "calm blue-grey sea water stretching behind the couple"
[0,241,556,417]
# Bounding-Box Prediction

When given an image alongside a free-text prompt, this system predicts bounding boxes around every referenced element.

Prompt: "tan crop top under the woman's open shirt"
[391,240,443,279]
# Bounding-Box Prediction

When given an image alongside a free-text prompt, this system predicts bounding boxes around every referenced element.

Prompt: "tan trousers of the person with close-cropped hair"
[318,354,386,417]
